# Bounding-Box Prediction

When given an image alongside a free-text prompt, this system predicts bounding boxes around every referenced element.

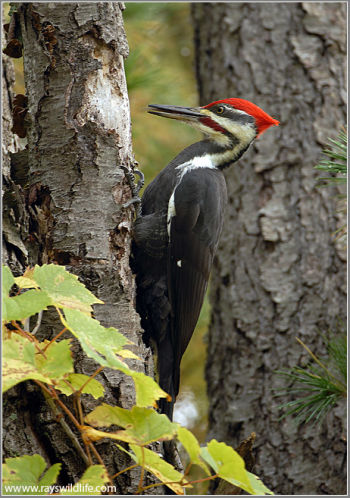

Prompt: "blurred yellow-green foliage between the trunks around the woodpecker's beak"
[124,2,200,182]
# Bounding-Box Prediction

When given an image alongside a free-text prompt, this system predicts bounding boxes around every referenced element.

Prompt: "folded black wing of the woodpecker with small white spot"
[168,169,227,394]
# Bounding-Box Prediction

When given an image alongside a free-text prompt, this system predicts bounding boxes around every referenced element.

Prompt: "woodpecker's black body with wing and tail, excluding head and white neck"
[134,141,227,418]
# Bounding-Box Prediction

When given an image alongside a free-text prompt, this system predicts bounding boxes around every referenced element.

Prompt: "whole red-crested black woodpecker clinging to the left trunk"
[134,98,279,420]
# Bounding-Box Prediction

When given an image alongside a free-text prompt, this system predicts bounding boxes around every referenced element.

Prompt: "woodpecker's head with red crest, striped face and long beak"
[148,98,279,148]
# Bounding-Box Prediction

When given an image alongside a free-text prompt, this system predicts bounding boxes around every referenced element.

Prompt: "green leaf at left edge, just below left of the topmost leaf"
[2,289,52,322]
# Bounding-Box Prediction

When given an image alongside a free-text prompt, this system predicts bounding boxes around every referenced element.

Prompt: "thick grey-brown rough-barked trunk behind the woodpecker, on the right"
[193,2,346,495]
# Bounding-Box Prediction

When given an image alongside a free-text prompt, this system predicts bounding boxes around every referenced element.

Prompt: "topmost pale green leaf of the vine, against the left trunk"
[33,264,103,313]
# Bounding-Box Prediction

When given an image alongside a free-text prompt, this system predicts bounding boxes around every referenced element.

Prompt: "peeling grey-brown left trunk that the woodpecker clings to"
[3,2,162,494]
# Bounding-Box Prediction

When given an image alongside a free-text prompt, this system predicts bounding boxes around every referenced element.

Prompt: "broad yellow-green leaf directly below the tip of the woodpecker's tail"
[85,403,177,445]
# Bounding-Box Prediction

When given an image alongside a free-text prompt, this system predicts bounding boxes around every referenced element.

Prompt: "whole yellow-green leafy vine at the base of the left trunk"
[3,265,272,495]
